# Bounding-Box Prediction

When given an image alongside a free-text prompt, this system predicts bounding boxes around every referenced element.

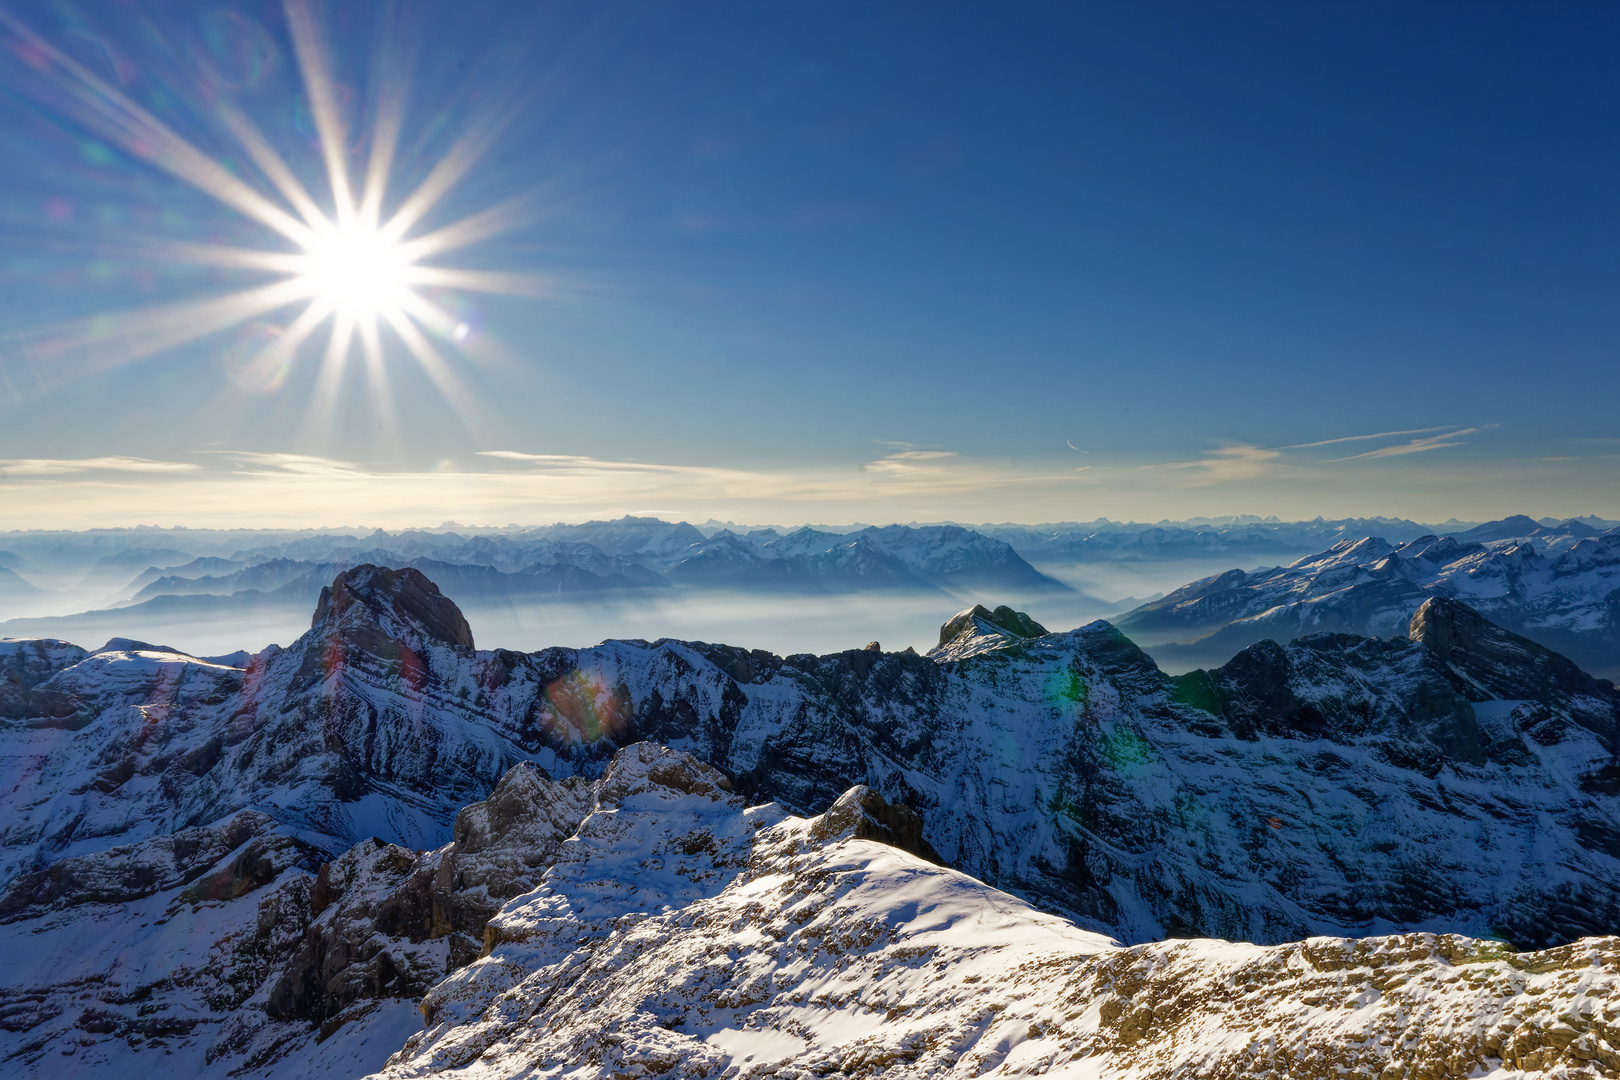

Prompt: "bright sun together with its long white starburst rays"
[0,0,556,423]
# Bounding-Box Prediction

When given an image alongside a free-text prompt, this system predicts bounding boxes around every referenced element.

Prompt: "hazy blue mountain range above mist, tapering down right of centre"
[0,518,1069,621]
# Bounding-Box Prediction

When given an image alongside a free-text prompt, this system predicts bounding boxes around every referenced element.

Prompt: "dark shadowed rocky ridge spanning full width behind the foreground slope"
[0,568,1620,946]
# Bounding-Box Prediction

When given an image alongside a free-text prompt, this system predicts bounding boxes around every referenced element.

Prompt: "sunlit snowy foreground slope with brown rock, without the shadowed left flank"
[381,751,1620,1078]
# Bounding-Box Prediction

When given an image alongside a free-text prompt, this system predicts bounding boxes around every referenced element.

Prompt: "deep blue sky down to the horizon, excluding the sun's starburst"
[0,3,1620,526]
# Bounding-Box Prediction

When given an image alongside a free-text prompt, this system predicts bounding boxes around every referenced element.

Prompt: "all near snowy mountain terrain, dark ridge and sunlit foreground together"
[0,567,1620,1077]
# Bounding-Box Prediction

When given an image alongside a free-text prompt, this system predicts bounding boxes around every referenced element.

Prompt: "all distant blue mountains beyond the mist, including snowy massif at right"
[0,515,1620,674]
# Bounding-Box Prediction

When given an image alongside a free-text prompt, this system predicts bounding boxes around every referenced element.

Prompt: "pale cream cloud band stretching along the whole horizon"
[0,427,1620,528]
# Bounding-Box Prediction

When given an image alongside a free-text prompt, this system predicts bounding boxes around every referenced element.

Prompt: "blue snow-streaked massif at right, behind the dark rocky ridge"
[1118,518,1620,675]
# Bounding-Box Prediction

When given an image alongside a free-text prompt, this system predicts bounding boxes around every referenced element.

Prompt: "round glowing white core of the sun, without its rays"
[296,217,415,324]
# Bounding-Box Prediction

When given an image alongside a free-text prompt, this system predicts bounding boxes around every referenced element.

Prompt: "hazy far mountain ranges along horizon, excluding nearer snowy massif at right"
[0,517,1614,615]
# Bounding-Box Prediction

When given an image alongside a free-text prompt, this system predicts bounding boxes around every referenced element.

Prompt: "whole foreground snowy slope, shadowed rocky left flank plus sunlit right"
[0,743,1620,1080]
